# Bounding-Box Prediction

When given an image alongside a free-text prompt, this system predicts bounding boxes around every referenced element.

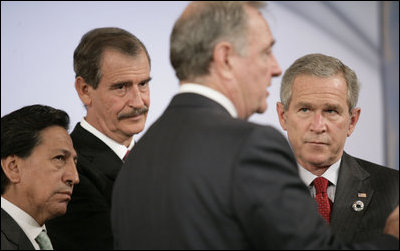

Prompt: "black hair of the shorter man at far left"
[1,105,69,194]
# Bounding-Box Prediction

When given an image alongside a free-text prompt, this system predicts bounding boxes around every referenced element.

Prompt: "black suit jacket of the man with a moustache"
[46,123,122,250]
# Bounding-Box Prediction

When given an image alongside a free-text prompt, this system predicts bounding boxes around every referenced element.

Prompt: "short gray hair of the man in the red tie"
[280,53,360,113]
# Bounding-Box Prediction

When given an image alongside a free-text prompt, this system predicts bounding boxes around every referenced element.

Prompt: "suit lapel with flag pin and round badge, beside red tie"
[331,152,374,239]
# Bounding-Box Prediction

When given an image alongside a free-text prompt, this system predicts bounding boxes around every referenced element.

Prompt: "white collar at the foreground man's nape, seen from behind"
[179,83,237,118]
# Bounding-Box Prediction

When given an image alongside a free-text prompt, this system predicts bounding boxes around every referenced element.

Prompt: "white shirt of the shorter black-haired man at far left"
[1,196,46,250]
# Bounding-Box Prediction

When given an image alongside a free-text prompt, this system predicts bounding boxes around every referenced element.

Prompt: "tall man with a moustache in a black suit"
[48,28,150,250]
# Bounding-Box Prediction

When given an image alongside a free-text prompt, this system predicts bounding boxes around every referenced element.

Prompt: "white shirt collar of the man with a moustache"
[81,118,135,160]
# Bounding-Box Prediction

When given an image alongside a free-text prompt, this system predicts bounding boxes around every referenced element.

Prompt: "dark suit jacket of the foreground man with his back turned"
[112,93,398,250]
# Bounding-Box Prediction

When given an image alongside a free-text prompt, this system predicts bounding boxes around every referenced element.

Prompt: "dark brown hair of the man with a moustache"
[74,27,150,89]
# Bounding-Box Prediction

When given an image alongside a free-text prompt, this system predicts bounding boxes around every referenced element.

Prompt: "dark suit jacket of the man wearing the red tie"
[331,153,399,242]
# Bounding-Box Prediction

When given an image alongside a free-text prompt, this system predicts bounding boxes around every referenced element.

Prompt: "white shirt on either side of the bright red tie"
[297,159,341,203]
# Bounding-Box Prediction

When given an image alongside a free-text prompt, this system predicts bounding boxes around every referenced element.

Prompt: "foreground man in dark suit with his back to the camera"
[112,2,398,250]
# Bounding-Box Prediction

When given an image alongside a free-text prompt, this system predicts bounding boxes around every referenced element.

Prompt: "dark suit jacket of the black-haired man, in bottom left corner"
[1,209,35,250]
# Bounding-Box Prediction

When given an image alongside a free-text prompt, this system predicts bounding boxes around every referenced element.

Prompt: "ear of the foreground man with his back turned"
[212,41,235,78]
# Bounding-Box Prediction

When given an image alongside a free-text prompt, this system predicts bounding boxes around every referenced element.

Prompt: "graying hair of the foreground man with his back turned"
[170,1,265,80]
